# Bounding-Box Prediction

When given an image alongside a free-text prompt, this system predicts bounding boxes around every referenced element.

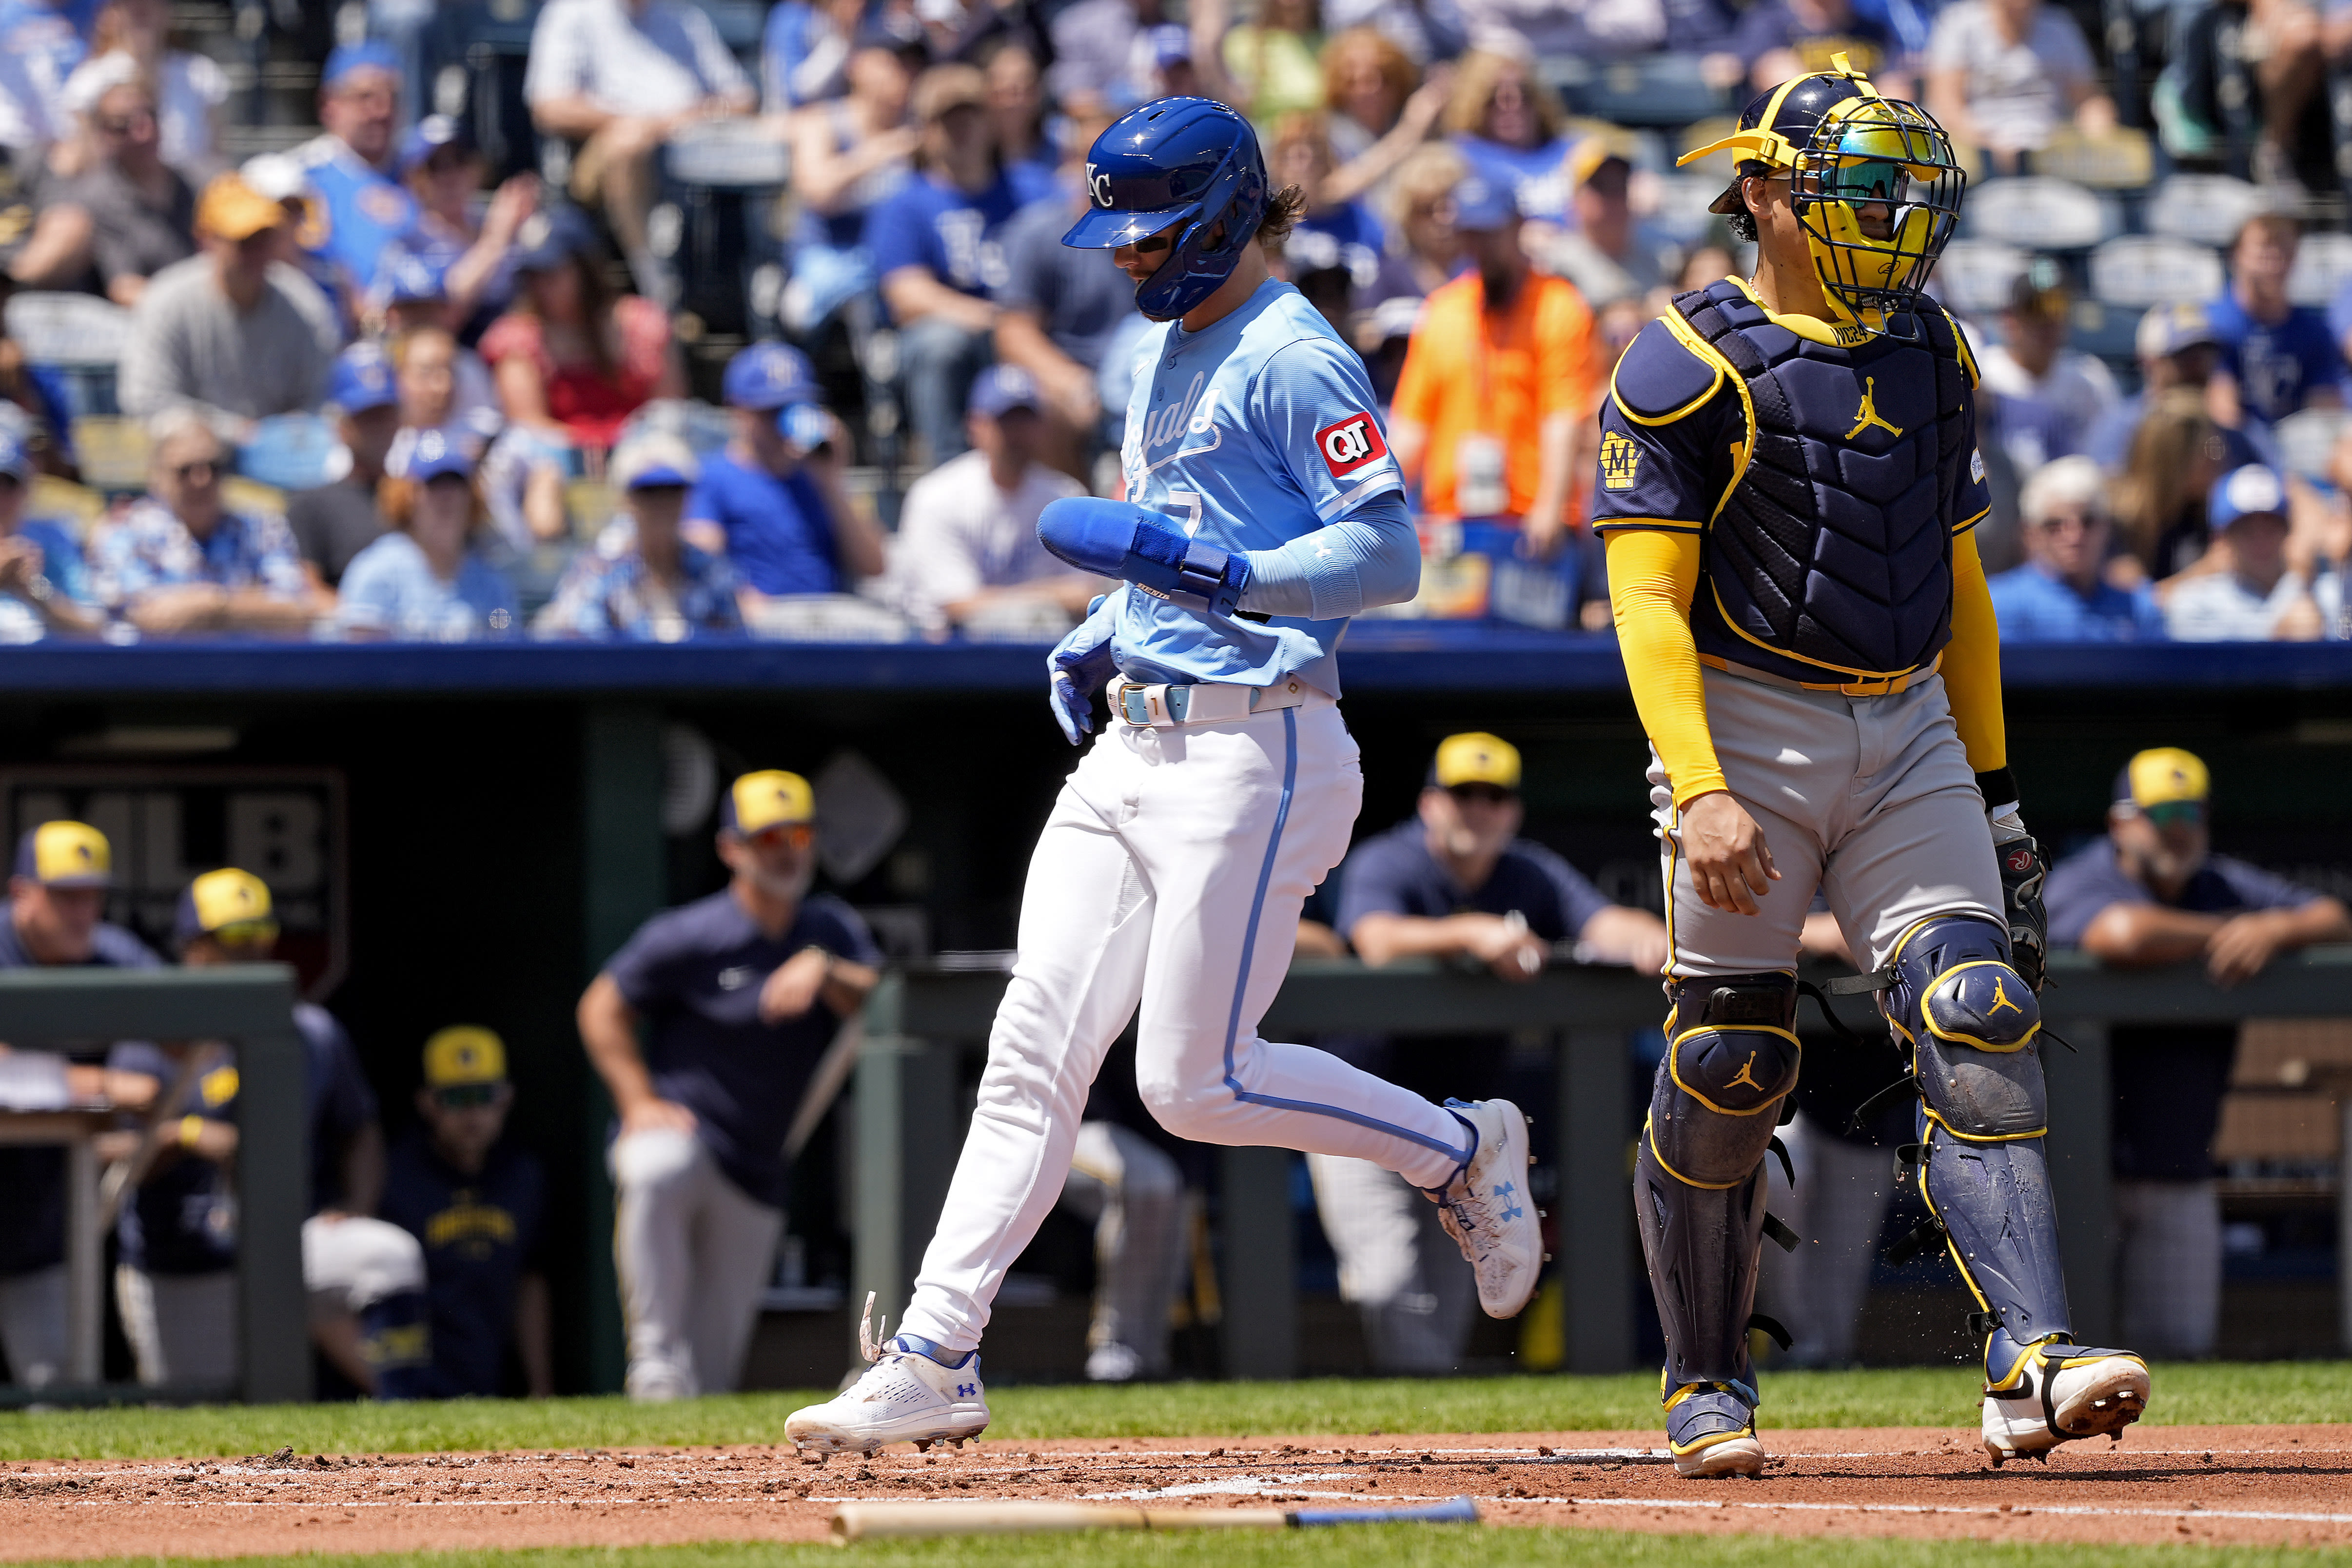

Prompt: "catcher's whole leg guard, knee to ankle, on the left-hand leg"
[1635,973,1797,1420]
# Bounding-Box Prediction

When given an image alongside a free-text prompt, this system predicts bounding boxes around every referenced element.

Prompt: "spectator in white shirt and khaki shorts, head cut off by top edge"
[522,0,757,306]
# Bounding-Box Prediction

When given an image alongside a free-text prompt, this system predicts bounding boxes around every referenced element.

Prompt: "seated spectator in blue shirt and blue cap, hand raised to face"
[680,343,884,616]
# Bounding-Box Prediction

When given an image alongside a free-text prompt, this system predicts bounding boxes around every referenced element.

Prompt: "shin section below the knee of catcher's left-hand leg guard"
[1632,1133,1771,1394]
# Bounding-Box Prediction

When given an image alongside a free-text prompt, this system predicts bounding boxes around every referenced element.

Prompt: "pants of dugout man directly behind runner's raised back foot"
[1308,1154,1477,1373]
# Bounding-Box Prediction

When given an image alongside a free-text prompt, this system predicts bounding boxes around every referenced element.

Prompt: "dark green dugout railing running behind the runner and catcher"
[851,947,2352,1377]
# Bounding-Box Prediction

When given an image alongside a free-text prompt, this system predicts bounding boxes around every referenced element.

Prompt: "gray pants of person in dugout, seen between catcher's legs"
[1757,1114,1896,1366]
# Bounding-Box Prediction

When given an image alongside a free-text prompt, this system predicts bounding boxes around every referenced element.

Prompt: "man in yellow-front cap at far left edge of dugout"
[0,823,162,1387]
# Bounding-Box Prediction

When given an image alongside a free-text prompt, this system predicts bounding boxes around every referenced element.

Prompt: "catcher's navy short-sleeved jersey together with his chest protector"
[1592,277,1990,684]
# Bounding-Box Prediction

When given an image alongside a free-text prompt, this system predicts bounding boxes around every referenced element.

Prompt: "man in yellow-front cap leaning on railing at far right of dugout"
[2049,745,2352,1356]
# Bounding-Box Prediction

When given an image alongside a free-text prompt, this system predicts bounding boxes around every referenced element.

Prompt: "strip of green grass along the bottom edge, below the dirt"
[27,1526,2352,1568]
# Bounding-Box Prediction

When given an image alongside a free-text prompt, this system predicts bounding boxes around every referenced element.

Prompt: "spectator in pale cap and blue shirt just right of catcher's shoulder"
[1992,456,2164,642]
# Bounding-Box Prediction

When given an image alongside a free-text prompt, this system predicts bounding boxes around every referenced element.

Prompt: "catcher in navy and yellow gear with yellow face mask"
[1595,54,2147,1476]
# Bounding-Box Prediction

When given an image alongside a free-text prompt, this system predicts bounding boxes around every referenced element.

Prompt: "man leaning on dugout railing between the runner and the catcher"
[1308,733,1667,1373]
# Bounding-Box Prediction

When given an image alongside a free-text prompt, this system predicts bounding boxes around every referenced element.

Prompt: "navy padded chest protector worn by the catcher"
[1675,280,1973,679]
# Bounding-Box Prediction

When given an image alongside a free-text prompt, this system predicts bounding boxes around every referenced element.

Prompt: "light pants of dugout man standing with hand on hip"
[609,1128,783,1399]
